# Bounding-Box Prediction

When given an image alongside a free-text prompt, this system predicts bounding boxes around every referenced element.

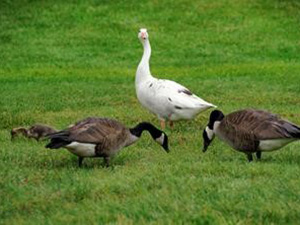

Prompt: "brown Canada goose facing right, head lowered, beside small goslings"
[46,117,169,167]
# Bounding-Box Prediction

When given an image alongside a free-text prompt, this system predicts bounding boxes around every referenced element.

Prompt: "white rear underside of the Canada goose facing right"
[66,141,96,157]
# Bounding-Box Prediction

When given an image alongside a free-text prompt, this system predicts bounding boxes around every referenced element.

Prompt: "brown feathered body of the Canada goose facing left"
[216,109,300,152]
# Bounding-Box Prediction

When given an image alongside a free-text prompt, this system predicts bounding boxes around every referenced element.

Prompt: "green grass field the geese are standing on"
[0,0,300,224]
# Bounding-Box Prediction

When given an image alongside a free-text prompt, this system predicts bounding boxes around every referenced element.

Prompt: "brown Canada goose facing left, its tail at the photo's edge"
[203,109,300,162]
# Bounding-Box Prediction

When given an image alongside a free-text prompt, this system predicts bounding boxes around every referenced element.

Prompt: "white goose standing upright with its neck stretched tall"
[135,29,215,129]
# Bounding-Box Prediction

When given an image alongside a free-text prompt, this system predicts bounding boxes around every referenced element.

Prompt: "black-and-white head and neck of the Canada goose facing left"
[202,110,224,152]
